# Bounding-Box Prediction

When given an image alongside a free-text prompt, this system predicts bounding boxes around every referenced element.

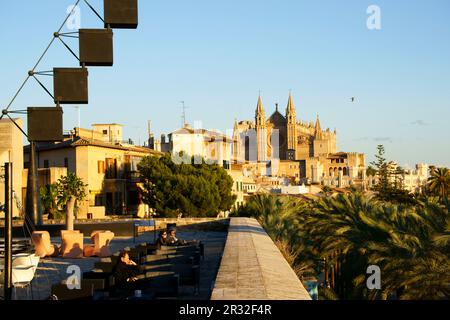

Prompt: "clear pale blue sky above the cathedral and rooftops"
[0,0,450,166]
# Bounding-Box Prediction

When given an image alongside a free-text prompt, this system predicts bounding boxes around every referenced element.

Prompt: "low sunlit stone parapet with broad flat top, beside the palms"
[211,218,311,300]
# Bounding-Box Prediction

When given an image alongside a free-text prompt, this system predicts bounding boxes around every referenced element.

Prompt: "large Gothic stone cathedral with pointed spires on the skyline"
[233,94,365,186]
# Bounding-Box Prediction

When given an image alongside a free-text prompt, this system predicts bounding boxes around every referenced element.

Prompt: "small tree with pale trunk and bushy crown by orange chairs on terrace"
[57,173,87,230]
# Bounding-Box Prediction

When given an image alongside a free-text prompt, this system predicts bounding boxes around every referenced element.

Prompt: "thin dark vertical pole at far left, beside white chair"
[4,162,13,300]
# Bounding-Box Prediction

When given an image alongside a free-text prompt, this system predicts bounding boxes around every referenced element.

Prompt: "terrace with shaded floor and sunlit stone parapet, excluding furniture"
[0,218,310,300]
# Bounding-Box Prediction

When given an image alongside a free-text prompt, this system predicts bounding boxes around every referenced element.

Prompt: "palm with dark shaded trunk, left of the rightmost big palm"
[304,193,389,299]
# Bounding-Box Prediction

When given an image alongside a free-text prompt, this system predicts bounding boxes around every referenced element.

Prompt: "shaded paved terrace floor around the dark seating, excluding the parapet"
[9,231,227,300]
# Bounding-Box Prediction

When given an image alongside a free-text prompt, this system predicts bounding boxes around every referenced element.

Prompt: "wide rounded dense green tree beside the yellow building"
[138,154,235,217]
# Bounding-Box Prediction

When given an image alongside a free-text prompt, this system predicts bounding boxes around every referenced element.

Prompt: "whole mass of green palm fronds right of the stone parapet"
[240,192,450,300]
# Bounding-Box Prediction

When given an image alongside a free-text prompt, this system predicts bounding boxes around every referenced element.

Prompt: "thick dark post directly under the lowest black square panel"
[26,141,42,229]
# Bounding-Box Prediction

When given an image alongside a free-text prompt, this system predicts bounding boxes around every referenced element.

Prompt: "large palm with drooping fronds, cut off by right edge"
[359,201,450,299]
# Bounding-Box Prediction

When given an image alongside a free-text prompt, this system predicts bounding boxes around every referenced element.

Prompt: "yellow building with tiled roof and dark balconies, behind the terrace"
[25,124,161,219]
